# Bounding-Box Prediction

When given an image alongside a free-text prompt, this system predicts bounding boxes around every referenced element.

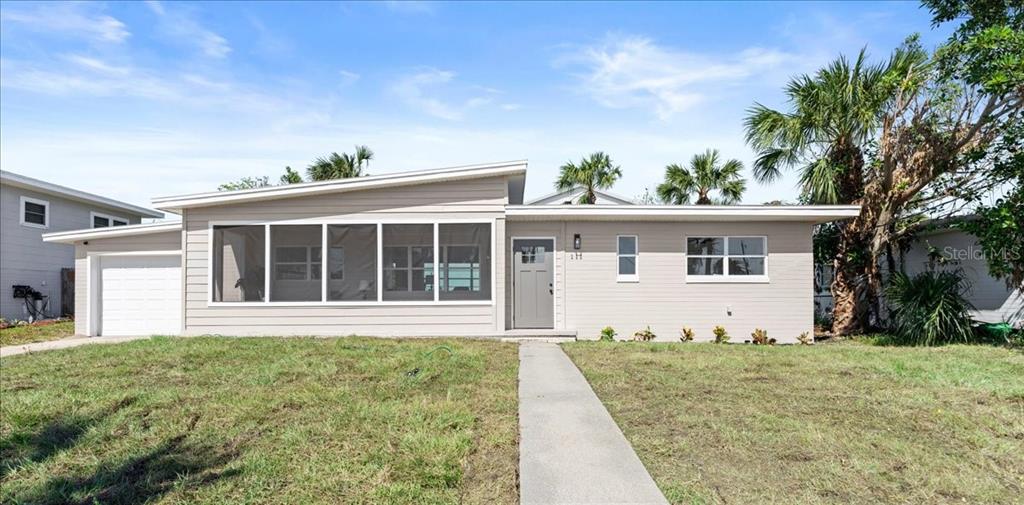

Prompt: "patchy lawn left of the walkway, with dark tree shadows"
[0,337,518,504]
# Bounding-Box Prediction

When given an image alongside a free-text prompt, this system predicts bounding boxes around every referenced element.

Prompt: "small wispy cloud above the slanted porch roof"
[391,69,494,121]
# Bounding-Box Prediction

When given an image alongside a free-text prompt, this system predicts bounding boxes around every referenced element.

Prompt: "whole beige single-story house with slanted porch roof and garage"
[46,162,858,342]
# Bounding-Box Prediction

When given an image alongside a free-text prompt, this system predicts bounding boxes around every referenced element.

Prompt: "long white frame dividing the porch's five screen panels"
[206,218,499,307]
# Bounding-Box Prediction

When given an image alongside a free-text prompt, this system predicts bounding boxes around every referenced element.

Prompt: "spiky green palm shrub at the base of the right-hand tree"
[886,270,974,345]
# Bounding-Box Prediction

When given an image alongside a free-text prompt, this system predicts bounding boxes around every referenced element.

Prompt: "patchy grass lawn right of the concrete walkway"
[563,342,1024,503]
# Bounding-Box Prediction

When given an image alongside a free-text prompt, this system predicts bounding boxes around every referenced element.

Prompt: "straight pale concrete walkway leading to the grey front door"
[519,342,668,504]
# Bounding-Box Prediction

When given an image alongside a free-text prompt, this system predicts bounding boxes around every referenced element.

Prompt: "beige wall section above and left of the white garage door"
[72,232,181,335]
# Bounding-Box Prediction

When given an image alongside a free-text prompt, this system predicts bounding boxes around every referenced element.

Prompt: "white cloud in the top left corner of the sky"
[0,2,131,43]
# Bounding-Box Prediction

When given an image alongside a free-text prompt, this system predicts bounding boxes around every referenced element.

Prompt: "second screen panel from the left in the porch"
[270,224,324,301]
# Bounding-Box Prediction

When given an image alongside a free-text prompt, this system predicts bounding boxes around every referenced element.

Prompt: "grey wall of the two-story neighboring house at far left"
[0,184,140,320]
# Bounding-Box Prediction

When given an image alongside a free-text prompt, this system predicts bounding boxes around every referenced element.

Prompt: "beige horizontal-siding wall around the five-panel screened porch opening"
[183,177,508,336]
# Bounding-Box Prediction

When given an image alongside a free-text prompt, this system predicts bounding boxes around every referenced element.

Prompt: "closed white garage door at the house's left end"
[99,255,181,335]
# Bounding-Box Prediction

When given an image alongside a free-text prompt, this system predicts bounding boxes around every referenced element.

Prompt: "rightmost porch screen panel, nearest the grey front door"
[437,223,490,300]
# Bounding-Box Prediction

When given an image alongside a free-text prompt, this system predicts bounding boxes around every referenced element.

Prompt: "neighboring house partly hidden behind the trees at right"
[815,220,1024,327]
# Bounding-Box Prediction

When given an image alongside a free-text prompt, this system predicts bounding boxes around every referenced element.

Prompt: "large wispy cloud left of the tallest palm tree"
[555,35,793,120]
